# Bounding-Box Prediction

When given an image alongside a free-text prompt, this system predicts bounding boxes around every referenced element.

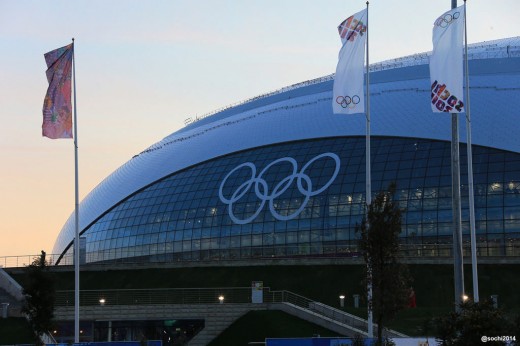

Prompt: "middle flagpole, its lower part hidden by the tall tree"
[365,1,374,338]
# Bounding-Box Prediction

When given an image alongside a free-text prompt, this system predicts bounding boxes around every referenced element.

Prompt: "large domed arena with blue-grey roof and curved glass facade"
[53,37,520,262]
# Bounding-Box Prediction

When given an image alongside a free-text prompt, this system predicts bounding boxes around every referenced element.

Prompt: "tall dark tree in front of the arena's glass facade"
[356,183,411,345]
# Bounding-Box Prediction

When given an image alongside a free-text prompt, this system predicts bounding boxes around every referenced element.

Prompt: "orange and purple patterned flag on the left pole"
[42,44,74,139]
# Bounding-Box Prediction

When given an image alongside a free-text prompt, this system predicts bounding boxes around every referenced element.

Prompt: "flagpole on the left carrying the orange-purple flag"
[72,38,79,343]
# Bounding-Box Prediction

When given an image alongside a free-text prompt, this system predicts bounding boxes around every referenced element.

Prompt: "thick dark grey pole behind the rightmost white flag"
[451,0,464,311]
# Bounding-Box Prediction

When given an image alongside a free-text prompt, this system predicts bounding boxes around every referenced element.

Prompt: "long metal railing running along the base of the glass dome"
[0,239,520,268]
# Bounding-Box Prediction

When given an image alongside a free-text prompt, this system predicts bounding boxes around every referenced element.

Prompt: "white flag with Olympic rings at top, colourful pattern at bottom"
[430,5,465,113]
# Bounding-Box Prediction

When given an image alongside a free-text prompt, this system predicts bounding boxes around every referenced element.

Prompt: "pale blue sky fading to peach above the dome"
[0,0,520,265]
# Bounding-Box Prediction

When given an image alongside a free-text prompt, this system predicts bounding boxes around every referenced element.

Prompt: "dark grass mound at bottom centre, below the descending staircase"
[209,310,338,346]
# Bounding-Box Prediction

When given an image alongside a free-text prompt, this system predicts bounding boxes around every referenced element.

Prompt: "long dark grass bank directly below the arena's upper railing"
[47,264,520,307]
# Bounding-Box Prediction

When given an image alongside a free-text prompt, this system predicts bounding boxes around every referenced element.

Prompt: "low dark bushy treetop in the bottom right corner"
[433,300,518,346]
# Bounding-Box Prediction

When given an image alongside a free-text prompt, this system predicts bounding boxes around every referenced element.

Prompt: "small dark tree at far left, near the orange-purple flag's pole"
[22,251,55,345]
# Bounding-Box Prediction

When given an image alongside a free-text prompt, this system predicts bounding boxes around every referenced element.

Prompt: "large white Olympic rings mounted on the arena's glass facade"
[218,153,340,225]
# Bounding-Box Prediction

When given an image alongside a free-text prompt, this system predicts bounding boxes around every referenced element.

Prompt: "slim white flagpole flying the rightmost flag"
[464,0,479,303]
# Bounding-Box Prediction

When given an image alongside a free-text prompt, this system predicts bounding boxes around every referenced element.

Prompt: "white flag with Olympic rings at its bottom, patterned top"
[332,9,368,114]
